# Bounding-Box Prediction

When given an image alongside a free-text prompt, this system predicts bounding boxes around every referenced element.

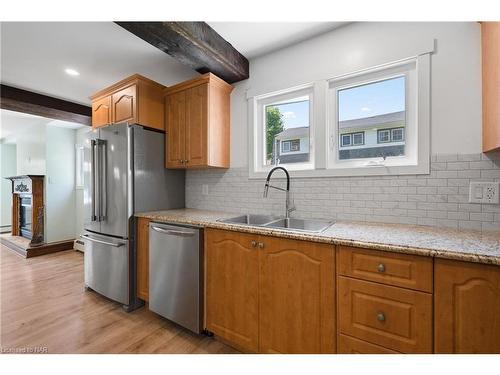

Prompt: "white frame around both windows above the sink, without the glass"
[247,53,433,179]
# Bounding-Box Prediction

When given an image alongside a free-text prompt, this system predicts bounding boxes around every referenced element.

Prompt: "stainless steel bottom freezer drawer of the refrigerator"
[82,232,129,305]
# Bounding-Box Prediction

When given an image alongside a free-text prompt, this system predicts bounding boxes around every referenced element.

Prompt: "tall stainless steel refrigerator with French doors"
[82,124,185,311]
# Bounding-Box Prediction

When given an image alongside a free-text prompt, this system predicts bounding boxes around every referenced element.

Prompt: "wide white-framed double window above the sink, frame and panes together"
[247,53,430,178]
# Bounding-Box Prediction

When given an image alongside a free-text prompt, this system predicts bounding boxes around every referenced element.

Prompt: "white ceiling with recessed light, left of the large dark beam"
[0,22,198,105]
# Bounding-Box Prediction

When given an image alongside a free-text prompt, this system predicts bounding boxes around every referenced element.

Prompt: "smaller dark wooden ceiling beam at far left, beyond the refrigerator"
[0,84,92,126]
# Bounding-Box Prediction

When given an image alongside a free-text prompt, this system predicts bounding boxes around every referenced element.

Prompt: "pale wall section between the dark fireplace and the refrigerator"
[45,122,76,242]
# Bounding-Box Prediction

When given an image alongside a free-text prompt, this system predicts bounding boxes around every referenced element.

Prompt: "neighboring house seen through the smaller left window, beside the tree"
[273,126,309,164]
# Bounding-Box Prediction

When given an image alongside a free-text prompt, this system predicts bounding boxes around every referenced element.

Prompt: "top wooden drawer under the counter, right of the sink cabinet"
[338,246,432,293]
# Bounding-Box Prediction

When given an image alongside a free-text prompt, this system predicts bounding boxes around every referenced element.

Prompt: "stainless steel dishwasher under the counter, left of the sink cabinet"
[149,222,203,333]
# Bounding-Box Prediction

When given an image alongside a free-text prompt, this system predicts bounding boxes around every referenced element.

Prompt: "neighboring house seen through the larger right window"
[339,111,406,159]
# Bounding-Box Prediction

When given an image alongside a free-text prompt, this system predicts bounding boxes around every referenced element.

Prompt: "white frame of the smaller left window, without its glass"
[249,84,315,178]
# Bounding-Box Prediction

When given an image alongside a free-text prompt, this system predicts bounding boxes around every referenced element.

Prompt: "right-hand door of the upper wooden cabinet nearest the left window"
[186,83,208,168]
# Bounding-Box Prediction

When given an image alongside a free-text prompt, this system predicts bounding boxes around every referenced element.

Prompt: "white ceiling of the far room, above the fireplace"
[0,109,86,144]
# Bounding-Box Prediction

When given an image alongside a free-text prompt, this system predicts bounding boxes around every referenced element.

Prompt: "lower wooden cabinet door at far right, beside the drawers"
[434,259,500,353]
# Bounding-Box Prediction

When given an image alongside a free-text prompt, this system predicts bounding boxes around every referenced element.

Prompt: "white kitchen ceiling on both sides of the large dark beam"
[0,22,345,105]
